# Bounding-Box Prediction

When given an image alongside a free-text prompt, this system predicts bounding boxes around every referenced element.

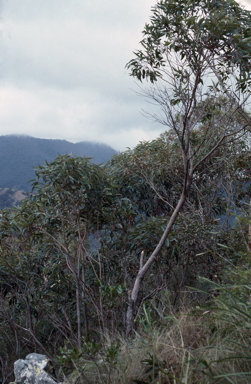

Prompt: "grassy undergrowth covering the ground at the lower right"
[57,268,251,384]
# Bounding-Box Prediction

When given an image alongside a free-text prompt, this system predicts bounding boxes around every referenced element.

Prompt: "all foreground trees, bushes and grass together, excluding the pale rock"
[0,0,251,384]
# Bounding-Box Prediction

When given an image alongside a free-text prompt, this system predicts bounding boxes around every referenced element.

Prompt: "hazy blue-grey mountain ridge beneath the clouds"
[0,135,117,192]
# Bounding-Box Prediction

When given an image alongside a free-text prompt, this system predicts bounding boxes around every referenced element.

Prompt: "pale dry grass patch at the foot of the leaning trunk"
[65,313,209,384]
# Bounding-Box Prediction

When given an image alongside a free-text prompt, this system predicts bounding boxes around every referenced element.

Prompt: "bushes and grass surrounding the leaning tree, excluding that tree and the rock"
[0,140,251,384]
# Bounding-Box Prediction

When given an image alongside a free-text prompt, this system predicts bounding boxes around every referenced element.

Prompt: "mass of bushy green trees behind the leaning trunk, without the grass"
[0,133,249,372]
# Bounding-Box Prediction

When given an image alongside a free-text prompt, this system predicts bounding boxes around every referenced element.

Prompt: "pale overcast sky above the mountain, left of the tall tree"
[0,0,251,151]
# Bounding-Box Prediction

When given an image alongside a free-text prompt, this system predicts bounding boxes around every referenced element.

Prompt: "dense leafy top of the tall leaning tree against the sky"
[127,0,251,92]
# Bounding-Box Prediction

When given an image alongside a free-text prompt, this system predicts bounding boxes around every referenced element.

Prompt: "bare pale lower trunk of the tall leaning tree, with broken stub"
[126,190,188,337]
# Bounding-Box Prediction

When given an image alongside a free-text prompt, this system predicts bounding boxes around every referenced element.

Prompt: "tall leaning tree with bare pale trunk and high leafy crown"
[126,0,251,335]
